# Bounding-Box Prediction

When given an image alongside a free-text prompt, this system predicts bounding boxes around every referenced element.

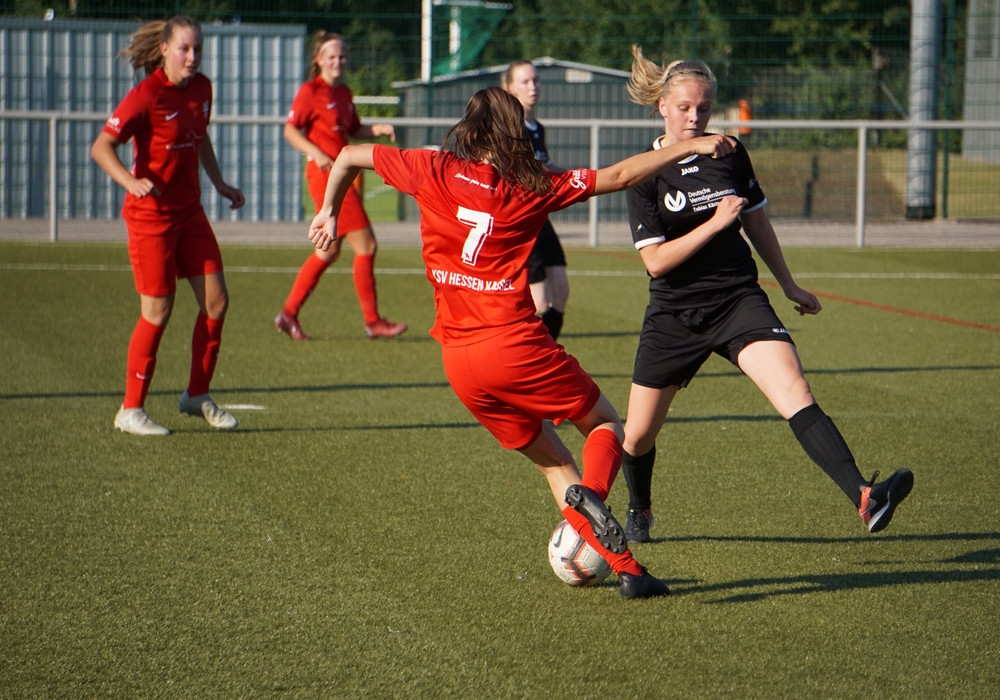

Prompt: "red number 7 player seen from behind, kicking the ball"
[309,87,733,598]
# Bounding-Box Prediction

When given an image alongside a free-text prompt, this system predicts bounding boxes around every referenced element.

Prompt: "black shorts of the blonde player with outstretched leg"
[632,287,794,389]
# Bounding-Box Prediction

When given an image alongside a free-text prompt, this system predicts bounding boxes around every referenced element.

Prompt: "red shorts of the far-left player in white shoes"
[125,207,222,297]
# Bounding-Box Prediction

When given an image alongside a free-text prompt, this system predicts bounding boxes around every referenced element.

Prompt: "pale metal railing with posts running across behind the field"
[0,110,1000,247]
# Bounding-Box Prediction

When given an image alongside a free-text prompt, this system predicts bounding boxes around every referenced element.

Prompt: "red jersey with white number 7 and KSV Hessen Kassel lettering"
[373,145,597,346]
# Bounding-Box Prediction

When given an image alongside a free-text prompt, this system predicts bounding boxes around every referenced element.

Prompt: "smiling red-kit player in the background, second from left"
[274,31,407,340]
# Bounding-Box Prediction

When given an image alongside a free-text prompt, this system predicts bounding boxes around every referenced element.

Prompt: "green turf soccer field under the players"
[0,243,1000,698]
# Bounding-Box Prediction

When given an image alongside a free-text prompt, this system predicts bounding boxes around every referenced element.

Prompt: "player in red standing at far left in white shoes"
[90,16,245,435]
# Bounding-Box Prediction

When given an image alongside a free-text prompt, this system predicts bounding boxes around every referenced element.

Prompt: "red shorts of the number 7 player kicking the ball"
[441,321,601,450]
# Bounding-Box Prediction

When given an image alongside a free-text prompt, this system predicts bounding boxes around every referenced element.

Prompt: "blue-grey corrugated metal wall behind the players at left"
[0,17,306,221]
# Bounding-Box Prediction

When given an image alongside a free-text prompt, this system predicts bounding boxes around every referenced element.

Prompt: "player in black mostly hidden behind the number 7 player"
[502,61,569,340]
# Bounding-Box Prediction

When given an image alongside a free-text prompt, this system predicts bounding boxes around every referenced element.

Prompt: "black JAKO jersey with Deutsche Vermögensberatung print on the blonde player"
[626,142,767,308]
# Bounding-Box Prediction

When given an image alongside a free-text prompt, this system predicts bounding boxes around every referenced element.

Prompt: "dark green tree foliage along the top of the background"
[0,0,967,117]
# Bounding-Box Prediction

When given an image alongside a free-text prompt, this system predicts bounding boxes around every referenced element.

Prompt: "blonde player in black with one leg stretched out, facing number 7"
[622,47,913,542]
